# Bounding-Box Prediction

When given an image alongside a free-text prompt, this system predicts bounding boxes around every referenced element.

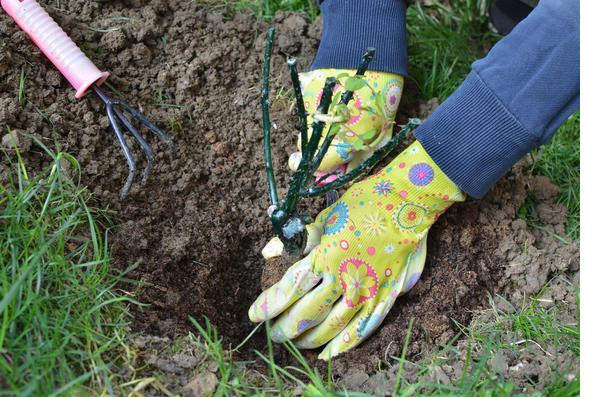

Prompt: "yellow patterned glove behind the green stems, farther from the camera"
[288,69,404,182]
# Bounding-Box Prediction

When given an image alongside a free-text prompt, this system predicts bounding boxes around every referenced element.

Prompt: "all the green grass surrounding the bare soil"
[0,0,579,396]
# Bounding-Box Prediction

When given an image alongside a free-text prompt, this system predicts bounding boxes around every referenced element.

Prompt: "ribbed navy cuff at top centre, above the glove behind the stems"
[311,0,408,76]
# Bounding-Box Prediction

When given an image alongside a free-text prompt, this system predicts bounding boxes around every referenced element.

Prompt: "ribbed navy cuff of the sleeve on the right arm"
[415,72,540,198]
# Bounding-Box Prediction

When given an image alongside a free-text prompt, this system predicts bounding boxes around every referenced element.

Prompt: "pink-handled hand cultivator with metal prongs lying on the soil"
[1,0,174,198]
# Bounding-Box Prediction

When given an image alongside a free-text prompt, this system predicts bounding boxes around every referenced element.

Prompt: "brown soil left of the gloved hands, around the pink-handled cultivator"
[0,1,320,341]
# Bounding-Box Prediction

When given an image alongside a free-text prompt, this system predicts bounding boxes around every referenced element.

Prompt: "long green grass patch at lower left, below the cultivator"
[0,138,136,396]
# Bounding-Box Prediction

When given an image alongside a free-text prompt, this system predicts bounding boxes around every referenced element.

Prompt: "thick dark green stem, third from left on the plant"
[283,77,336,214]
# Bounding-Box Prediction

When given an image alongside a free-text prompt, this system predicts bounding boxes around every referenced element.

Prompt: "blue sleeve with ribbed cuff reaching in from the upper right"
[416,0,579,198]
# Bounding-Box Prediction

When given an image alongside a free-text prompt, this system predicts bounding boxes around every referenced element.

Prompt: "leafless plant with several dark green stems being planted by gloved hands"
[262,29,420,256]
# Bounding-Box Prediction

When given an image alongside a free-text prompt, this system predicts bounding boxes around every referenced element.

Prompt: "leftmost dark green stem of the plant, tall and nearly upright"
[261,28,279,207]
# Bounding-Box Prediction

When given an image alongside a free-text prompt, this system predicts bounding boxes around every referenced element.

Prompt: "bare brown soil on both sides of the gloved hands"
[0,0,580,384]
